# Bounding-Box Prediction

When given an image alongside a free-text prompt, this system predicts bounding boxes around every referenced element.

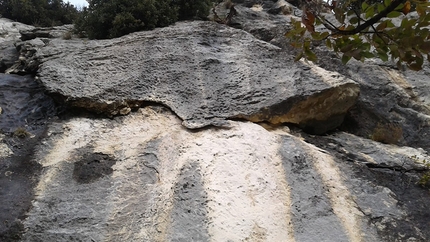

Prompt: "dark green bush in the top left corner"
[0,0,78,26]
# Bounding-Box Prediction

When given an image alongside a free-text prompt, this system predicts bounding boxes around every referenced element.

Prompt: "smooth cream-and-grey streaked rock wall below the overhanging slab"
[21,107,430,242]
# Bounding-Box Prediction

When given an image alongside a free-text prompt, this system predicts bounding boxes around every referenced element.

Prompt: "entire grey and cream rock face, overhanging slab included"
[0,1,430,242]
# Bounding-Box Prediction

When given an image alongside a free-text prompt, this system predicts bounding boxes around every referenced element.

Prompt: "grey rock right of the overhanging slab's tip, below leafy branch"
[321,55,430,152]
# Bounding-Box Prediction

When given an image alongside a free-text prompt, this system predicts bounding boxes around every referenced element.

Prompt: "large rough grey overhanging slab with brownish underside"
[37,21,359,133]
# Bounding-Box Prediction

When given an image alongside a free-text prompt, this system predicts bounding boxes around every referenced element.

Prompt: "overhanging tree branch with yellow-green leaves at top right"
[286,0,430,70]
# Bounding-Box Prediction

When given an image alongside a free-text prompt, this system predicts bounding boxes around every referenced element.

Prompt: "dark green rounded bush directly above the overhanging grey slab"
[75,0,212,39]
